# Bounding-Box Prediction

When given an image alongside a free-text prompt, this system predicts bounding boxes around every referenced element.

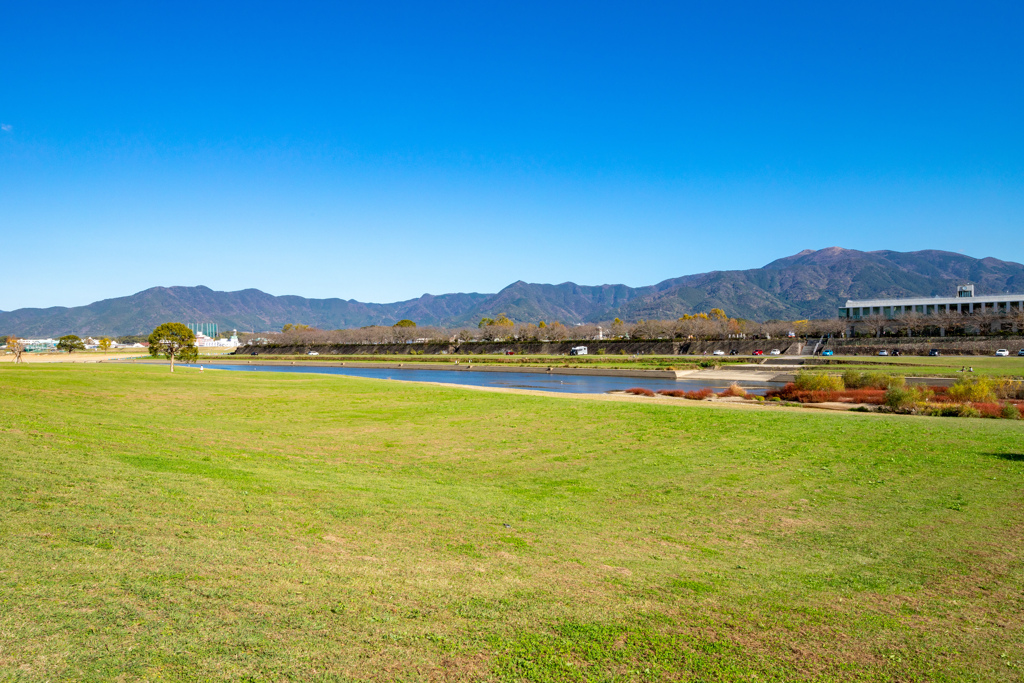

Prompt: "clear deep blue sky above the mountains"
[0,0,1024,310]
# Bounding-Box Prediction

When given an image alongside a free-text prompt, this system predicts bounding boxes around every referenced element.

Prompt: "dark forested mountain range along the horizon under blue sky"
[0,247,1024,337]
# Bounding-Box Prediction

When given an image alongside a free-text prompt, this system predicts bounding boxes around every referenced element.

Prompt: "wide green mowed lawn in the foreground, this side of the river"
[0,365,1024,681]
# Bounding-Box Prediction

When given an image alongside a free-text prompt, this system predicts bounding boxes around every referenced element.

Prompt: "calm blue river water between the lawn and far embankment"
[193,365,781,394]
